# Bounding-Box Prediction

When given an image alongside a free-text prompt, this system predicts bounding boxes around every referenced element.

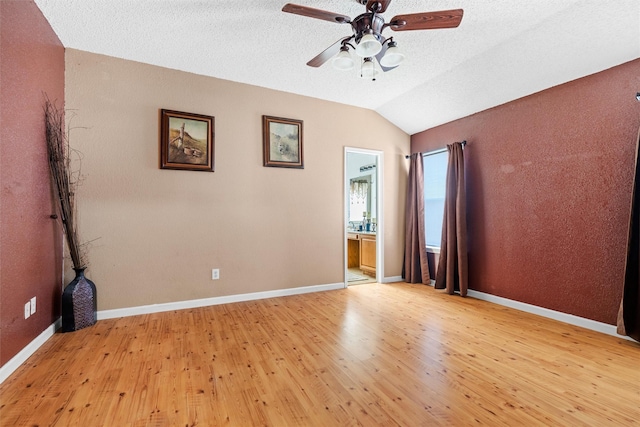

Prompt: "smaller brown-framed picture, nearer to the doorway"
[262,116,304,169]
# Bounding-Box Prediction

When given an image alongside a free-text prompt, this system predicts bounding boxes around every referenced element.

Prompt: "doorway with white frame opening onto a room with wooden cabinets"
[344,147,384,288]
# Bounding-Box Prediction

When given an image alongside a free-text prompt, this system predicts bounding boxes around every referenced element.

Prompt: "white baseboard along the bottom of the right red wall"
[467,289,631,340]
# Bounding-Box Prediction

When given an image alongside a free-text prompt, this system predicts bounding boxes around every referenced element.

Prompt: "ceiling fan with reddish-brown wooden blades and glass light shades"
[282,0,463,80]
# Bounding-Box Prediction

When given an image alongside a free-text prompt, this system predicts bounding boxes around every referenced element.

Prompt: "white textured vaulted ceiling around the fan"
[35,0,640,134]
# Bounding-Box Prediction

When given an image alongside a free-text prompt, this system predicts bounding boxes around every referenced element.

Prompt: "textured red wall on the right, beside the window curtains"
[411,60,640,324]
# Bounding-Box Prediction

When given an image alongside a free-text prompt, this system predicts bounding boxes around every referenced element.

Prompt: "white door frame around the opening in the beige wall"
[342,146,384,288]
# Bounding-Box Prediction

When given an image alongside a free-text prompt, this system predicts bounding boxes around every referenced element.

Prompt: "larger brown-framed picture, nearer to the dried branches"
[160,109,215,172]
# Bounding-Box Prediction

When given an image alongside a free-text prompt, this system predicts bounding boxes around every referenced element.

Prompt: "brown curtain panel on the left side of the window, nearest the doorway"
[402,153,431,284]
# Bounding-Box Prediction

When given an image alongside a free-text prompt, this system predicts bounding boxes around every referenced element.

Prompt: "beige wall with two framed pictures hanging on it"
[65,49,410,310]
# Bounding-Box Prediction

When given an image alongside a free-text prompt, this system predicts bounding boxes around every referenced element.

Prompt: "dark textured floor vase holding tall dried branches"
[60,268,98,332]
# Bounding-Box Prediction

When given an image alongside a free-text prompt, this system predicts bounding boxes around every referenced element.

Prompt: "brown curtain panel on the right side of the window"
[435,142,468,297]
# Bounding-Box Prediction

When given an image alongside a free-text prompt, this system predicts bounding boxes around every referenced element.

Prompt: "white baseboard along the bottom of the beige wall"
[98,283,344,320]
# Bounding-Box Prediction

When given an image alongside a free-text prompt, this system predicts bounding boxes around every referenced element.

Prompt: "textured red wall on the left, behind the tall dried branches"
[0,0,64,365]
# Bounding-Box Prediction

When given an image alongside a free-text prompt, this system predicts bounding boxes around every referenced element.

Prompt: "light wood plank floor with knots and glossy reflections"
[0,284,640,427]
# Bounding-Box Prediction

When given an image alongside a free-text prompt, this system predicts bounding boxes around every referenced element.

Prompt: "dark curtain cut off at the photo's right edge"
[618,125,640,341]
